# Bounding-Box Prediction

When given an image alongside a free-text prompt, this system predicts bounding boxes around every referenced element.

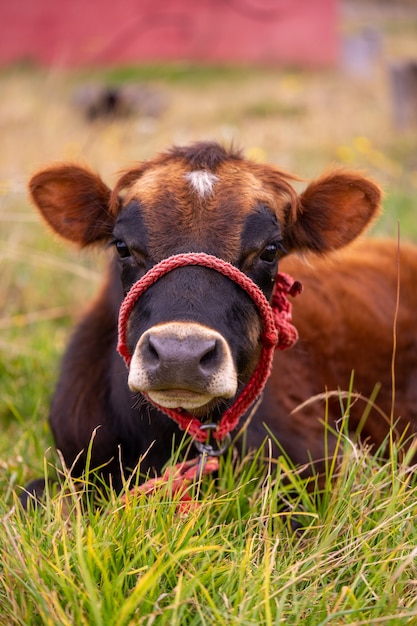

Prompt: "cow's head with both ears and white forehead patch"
[30,143,380,417]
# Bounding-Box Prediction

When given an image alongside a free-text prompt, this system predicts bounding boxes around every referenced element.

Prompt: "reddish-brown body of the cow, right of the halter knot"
[265,240,417,463]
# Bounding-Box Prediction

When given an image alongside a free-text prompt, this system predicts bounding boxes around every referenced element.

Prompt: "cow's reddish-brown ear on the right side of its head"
[284,170,382,254]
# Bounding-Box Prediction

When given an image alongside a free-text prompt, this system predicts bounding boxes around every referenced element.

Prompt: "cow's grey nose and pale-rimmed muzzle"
[128,322,237,408]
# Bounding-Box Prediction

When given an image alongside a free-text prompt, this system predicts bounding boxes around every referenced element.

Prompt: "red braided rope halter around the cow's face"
[117,252,302,442]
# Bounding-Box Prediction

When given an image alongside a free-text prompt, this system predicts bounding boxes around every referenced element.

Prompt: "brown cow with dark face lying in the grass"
[22,143,417,502]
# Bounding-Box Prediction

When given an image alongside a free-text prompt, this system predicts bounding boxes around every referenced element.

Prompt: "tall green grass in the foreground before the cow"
[0,432,417,626]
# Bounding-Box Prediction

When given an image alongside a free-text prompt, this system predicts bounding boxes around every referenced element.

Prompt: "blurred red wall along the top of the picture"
[0,0,338,66]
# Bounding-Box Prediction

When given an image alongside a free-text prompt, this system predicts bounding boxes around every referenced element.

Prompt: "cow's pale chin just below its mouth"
[147,389,225,417]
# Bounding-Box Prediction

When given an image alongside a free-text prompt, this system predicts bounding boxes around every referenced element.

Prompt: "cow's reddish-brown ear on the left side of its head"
[29,164,115,246]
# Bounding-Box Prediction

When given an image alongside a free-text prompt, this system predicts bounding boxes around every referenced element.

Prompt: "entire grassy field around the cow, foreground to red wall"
[0,3,417,626]
